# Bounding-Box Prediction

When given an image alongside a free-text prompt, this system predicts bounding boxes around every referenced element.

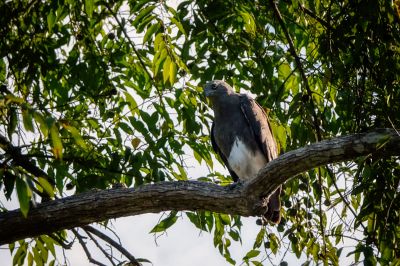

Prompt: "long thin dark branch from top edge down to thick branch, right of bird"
[270,0,322,141]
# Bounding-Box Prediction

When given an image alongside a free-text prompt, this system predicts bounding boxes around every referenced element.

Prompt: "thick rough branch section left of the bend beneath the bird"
[0,181,244,245]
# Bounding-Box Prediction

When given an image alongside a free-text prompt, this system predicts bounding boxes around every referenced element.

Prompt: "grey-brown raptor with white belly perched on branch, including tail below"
[204,80,282,224]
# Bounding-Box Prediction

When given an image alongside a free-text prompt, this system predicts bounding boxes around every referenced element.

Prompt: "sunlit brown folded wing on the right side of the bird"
[240,94,278,162]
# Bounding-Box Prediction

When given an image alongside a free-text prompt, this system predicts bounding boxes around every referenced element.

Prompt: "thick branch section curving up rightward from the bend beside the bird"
[244,129,400,202]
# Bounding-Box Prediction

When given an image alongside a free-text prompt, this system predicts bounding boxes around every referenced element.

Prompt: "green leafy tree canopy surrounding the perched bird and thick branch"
[0,0,400,265]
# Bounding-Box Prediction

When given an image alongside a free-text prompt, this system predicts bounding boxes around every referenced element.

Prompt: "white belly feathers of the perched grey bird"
[228,138,267,180]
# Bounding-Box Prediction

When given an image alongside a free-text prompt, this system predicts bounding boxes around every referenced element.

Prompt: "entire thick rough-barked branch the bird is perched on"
[0,129,400,245]
